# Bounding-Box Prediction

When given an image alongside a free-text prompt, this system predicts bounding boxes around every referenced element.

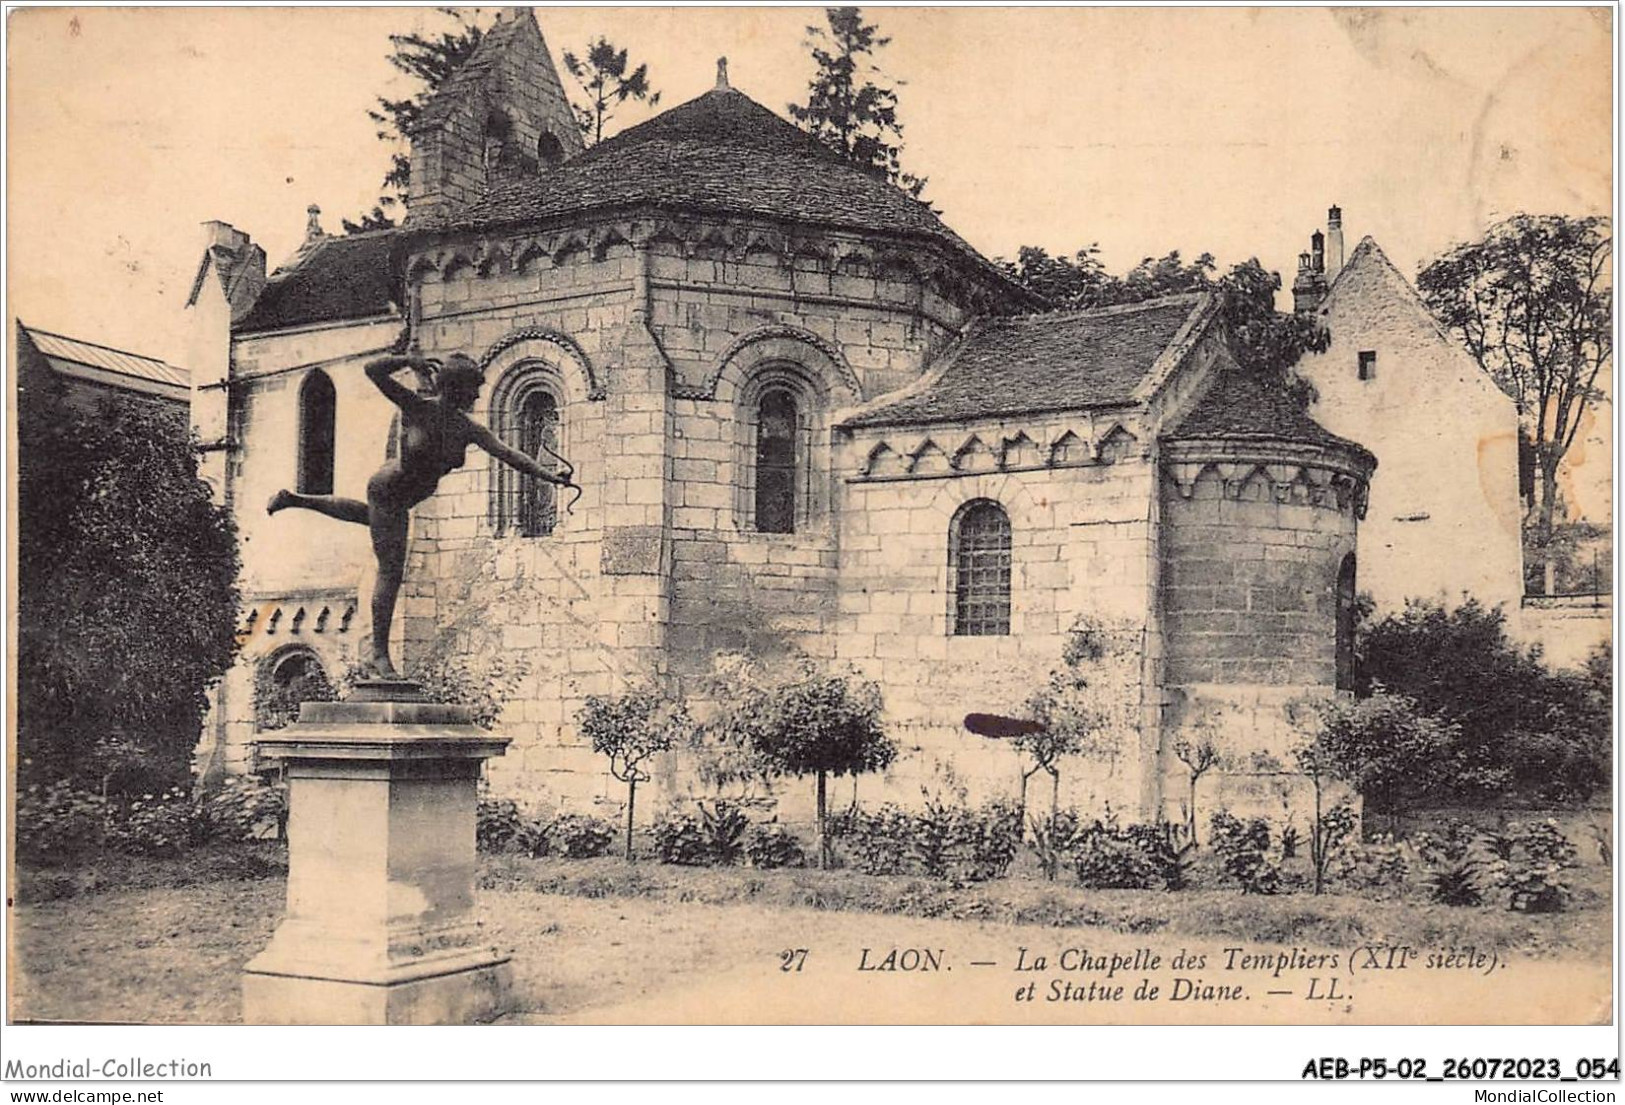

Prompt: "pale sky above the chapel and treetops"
[7,7,1614,513]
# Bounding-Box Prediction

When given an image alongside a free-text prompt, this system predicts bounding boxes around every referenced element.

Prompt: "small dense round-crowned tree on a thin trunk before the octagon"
[712,663,897,868]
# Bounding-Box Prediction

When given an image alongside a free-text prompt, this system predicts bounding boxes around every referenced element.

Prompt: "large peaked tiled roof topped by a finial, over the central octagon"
[408,88,996,271]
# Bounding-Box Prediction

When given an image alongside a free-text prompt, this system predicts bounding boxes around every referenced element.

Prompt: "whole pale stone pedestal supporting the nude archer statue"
[242,683,507,1024]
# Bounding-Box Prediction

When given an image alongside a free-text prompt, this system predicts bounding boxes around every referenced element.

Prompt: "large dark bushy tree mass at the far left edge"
[16,382,239,793]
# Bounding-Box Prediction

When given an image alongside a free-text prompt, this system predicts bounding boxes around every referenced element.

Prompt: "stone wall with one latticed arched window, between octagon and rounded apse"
[835,414,1155,816]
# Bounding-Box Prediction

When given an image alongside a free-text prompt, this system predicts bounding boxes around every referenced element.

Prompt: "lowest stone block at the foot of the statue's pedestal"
[242,959,512,1024]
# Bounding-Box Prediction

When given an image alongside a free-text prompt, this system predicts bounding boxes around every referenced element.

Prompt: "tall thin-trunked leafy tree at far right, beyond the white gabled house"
[1417,215,1614,583]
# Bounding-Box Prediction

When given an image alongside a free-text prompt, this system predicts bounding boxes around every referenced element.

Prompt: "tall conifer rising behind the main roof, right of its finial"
[790,8,926,198]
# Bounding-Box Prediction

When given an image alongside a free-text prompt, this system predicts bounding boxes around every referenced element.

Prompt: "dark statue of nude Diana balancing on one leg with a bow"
[267,353,580,679]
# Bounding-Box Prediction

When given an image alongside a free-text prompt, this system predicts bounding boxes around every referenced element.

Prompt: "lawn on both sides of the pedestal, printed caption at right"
[11,848,1610,1024]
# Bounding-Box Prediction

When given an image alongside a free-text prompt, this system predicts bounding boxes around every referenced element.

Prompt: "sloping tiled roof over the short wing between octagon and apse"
[845,296,1206,426]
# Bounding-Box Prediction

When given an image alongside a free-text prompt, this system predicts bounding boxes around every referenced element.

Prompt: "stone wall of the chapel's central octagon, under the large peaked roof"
[383,224,988,813]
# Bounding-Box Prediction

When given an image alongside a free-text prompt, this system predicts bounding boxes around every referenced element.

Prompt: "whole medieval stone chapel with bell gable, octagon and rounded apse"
[190,10,1375,819]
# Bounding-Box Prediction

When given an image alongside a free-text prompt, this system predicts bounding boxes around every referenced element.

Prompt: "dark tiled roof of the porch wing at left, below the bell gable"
[234,231,398,333]
